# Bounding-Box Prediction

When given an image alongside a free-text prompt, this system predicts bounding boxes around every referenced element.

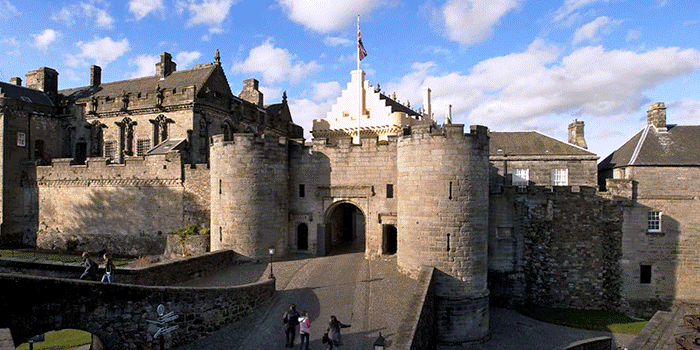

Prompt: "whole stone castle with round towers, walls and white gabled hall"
[0,51,700,343]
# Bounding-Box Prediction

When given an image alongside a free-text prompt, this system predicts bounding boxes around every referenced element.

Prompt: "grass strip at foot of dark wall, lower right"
[518,307,647,334]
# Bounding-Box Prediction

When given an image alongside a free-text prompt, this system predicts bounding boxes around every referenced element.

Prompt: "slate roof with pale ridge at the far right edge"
[598,125,700,170]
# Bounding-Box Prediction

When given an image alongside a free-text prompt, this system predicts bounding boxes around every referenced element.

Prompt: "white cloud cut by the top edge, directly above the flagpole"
[277,0,389,33]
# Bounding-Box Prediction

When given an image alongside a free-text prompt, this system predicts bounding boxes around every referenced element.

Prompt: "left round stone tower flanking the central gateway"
[210,134,289,259]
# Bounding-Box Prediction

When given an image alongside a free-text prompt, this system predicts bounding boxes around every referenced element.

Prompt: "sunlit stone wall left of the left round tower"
[35,152,209,256]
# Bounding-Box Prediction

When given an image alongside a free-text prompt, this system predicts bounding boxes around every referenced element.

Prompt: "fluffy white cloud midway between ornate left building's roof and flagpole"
[231,40,321,83]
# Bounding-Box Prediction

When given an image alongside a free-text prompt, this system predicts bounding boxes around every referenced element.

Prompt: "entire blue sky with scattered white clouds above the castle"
[0,0,700,158]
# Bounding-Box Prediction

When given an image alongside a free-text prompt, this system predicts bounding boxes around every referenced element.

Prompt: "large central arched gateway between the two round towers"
[325,202,365,254]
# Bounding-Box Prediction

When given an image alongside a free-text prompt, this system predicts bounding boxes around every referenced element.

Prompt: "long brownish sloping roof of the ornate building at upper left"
[59,63,216,101]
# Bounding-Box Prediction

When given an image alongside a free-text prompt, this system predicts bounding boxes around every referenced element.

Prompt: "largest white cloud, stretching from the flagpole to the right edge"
[387,40,700,130]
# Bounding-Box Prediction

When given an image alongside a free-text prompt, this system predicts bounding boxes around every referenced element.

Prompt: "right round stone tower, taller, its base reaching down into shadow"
[397,124,489,343]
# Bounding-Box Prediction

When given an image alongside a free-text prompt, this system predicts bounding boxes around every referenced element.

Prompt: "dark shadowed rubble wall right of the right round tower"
[489,187,627,310]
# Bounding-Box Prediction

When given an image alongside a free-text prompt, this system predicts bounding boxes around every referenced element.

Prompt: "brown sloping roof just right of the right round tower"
[489,131,596,157]
